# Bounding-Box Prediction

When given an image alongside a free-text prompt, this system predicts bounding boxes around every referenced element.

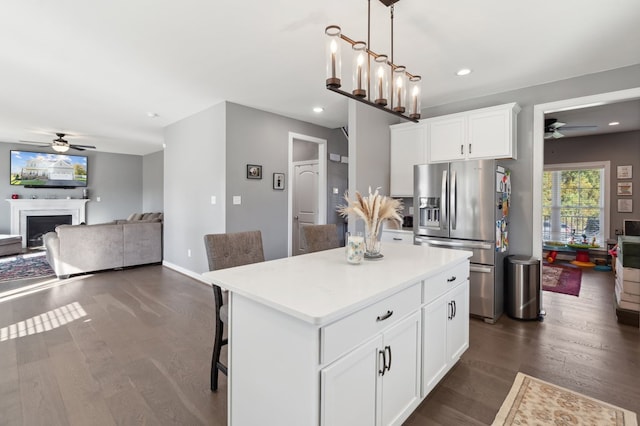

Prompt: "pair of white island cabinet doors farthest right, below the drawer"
[422,277,469,398]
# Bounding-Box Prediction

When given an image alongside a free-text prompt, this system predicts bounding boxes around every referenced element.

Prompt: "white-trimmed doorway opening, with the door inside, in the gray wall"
[287,132,327,256]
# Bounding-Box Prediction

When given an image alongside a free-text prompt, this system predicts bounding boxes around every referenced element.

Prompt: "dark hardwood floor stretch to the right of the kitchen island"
[406,268,640,425]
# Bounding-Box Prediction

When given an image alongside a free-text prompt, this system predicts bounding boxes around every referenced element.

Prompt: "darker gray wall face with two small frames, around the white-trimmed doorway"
[226,102,347,259]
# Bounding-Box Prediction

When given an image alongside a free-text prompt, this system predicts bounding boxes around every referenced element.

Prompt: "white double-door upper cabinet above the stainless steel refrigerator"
[427,103,520,163]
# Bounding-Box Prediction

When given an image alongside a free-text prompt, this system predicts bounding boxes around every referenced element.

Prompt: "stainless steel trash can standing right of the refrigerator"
[505,255,542,320]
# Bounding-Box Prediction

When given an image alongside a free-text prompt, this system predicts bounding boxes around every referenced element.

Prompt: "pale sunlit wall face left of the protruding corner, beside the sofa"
[164,103,226,273]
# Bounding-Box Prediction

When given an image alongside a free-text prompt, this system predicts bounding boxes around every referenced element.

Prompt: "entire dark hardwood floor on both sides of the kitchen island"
[0,265,640,425]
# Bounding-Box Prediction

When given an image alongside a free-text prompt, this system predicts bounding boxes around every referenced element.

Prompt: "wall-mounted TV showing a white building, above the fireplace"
[9,150,88,188]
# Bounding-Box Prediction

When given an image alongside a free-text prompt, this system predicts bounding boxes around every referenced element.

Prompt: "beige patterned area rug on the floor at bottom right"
[492,373,638,426]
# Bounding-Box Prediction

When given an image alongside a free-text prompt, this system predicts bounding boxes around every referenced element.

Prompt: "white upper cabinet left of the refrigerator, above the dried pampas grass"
[389,122,427,197]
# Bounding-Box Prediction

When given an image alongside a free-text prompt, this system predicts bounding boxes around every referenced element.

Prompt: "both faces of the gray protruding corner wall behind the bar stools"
[164,102,347,274]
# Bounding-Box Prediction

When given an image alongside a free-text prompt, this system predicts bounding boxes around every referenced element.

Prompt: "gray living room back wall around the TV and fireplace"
[0,143,143,234]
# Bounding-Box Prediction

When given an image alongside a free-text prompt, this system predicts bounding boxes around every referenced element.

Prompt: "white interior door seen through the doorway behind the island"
[292,161,319,256]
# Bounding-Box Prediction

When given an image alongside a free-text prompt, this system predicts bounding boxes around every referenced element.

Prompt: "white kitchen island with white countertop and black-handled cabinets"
[203,244,472,426]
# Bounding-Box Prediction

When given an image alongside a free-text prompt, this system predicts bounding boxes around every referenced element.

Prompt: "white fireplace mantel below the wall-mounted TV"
[7,198,89,247]
